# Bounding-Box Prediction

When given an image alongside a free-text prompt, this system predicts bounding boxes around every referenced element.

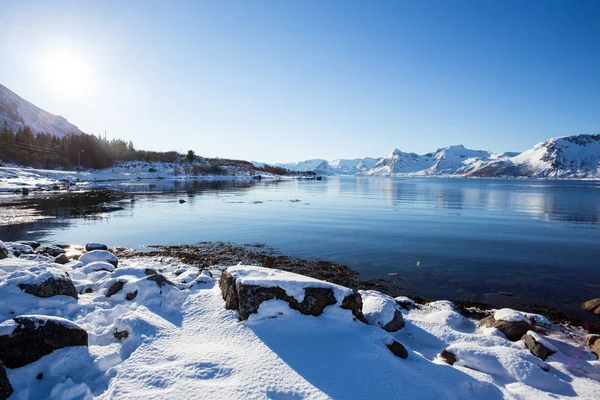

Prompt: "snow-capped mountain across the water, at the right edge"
[463,134,600,178]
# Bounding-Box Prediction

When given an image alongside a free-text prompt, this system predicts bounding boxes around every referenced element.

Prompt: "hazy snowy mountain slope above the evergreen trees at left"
[0,84,82,137]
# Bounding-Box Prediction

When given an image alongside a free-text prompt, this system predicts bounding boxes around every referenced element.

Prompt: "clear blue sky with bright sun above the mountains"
[0,0,600,162]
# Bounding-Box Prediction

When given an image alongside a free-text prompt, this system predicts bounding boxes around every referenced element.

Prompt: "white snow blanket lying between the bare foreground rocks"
[0,252,600,399]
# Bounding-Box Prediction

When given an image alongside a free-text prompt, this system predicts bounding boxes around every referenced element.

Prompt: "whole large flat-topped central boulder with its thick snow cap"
[219,266,365,322]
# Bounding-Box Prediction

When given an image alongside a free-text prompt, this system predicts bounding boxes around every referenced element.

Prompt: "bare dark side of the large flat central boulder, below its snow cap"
[219,271,365,322]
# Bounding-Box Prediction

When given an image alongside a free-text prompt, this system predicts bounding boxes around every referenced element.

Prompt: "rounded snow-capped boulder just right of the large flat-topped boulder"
[359,290,404,332]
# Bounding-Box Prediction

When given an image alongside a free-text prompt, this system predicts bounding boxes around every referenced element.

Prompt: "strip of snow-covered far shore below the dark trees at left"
[0,162,281,193]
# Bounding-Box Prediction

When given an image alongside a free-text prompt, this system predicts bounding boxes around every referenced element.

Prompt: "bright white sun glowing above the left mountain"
[40,48,94,98]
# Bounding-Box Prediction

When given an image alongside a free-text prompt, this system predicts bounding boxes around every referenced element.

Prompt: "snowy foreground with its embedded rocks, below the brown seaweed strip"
[0,242,600,399]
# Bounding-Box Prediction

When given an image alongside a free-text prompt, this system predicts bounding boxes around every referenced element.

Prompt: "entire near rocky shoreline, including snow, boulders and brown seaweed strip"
[0,241,600,400]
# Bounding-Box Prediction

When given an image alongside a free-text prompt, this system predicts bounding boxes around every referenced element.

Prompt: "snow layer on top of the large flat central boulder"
[227,265,353,303]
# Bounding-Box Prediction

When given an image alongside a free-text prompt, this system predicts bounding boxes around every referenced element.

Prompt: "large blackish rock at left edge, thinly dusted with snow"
[0,315,88,368]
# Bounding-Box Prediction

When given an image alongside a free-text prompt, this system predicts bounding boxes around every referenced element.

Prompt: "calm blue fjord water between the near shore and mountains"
[0,177,600,313]
